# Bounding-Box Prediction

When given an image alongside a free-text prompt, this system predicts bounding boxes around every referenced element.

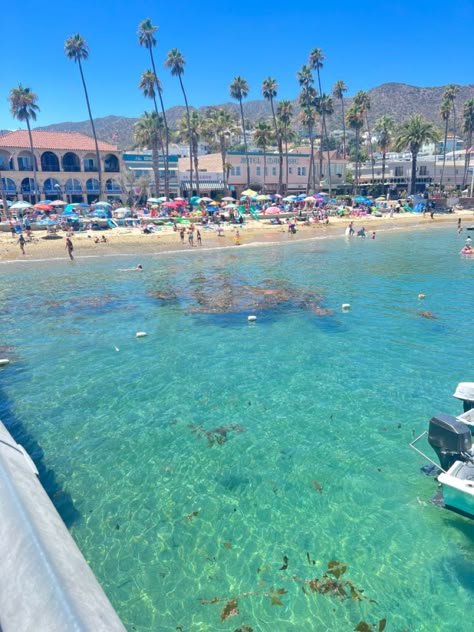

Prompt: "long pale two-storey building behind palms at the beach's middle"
[192,151,347,195]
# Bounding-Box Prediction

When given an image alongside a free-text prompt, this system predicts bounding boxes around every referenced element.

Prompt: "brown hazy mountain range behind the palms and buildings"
[17,83,474,150]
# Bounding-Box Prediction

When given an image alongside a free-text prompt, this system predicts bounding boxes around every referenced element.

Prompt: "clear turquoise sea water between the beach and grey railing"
[0,227,474,632]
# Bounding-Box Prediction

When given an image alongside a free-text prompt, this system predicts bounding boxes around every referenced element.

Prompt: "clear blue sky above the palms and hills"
[0,0,474,129]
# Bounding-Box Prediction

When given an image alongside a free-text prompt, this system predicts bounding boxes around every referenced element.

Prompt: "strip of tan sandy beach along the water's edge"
[0,210,474,262]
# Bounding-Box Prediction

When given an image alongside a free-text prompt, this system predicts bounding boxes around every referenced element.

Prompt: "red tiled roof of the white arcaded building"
[0,130,118,151]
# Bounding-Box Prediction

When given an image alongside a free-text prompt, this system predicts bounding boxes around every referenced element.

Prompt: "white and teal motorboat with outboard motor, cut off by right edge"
[410,382,474,519]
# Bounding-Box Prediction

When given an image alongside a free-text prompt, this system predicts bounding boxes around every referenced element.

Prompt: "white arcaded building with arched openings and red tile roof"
[0,130,122,204]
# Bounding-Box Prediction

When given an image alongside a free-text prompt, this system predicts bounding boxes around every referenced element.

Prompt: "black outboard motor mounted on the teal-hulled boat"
[428,413,472,470]
